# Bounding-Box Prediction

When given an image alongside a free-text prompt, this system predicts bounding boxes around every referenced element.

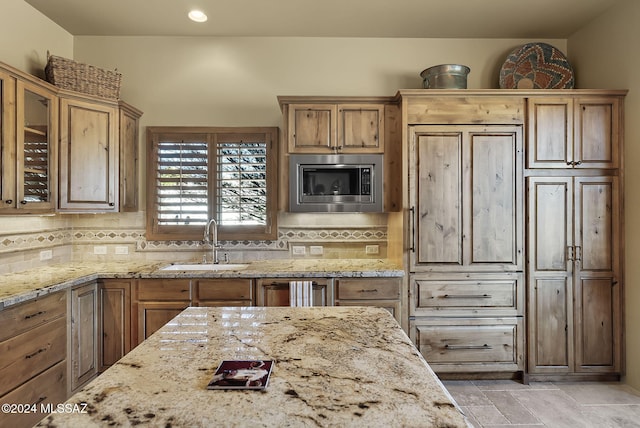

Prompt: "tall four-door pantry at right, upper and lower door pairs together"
[526,94,623,378]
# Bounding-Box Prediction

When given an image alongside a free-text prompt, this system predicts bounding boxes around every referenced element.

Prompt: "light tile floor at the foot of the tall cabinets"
[443,380,640,428]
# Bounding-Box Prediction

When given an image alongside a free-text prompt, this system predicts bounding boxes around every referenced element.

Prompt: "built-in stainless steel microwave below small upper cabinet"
[289,154,383,212]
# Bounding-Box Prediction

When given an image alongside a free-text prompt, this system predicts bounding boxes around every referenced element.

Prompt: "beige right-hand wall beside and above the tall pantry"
[568,0,640,389]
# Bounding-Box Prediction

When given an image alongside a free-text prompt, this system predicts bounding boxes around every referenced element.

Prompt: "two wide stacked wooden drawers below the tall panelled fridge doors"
[409,272,526,379]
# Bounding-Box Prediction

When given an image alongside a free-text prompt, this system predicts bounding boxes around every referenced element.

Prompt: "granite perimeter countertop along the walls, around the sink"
[0,259,404,310]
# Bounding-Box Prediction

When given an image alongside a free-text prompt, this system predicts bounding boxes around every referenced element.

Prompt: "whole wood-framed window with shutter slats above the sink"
[147,127,278,240]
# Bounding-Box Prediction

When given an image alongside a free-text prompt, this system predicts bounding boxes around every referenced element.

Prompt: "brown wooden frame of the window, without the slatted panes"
[146,126,279,241]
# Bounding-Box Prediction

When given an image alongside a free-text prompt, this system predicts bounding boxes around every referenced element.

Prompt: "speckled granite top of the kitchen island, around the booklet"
[38,307,470,428]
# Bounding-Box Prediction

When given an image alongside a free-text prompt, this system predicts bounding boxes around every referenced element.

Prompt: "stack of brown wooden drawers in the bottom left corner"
[0,291,68,427]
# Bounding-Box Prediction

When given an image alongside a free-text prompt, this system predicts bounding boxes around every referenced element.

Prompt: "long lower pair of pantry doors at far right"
[527,176,622,374]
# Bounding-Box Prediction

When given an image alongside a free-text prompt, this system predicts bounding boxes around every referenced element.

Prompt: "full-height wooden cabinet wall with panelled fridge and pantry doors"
[398,90,626,380]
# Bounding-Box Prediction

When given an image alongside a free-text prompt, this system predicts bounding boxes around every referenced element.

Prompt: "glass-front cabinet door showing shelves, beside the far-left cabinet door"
[15,81,58,212]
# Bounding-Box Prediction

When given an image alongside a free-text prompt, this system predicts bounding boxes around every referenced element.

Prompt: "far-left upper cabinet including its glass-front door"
[0,69,58,214]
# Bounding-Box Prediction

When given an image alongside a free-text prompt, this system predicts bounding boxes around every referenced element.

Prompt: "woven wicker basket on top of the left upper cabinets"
[44,55,122,100]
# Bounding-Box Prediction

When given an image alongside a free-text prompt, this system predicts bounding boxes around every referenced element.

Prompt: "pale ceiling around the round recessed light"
[25,0,620,39]
